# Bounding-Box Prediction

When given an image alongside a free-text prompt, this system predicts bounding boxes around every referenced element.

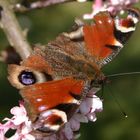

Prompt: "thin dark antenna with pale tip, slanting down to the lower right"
[108,87,128,118]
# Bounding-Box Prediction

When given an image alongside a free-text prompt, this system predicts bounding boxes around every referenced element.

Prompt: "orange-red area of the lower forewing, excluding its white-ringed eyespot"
[21,78,84,114]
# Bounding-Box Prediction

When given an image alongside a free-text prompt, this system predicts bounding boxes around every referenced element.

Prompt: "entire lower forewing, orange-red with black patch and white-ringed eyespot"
[20,78,85,134]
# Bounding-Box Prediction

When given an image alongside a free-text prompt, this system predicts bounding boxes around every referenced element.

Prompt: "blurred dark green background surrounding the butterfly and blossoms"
[0,2,140,140]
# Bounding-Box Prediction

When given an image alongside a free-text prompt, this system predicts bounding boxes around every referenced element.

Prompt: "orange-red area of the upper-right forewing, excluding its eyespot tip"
[83,12,117,59]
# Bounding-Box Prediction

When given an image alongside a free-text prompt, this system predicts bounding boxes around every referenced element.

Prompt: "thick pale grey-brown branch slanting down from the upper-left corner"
[0,0,32,59]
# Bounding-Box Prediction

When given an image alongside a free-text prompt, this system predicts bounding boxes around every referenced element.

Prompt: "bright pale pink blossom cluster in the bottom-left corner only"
[0,103,35,140]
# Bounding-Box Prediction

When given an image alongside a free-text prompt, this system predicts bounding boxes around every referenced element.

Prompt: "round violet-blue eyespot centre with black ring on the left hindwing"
[18,71,37,85]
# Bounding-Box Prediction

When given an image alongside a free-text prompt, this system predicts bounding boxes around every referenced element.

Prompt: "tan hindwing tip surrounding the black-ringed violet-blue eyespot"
[8,64,47,89]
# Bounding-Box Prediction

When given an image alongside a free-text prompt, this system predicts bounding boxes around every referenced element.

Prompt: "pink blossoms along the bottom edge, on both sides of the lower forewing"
[0,88,102,140]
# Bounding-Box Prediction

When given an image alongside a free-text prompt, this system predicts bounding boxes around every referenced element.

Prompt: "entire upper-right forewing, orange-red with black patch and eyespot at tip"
[83,9,139,65]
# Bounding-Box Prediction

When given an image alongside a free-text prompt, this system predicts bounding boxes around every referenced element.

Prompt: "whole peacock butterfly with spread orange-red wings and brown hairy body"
[8,9,140,135]
